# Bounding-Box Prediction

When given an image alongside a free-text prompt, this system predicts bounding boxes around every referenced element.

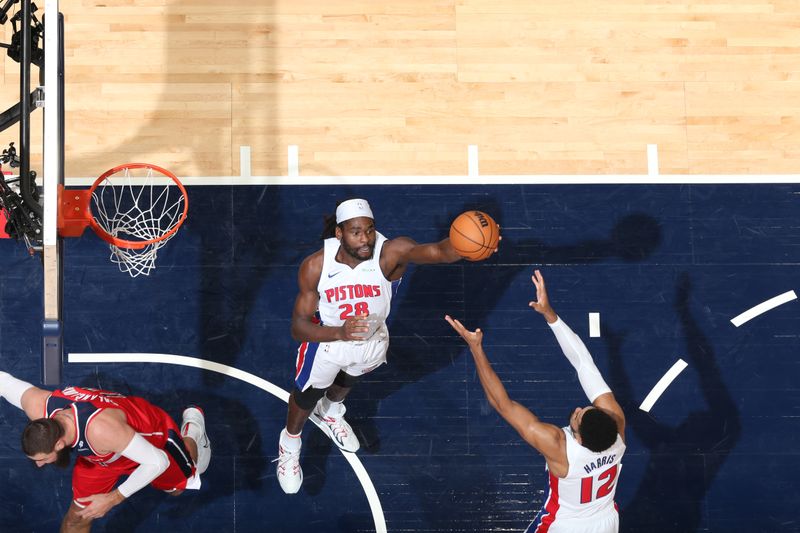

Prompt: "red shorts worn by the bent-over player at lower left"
[72,420,195,507]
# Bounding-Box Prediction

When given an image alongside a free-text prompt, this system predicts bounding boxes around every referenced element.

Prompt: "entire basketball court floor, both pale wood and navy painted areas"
[0,0,800,533]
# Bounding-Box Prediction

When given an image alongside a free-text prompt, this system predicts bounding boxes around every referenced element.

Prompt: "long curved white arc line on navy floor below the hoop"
[67,353,386,533]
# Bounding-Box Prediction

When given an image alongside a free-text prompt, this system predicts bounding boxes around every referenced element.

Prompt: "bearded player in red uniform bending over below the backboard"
[0,372,211,533]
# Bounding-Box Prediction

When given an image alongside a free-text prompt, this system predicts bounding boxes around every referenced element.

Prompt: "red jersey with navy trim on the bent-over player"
[44,387,171,465]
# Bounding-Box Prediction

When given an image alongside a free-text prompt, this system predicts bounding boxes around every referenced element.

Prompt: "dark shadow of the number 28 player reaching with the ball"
[350,206,662,452]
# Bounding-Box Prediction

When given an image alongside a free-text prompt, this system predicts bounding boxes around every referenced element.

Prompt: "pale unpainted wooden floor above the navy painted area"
[0,0,800,177]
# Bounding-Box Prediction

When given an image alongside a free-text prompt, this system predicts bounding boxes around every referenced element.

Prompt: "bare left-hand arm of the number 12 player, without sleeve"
[445,316,568,476]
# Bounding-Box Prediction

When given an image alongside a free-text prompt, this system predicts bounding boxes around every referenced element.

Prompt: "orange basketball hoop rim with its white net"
[92,165,186,277]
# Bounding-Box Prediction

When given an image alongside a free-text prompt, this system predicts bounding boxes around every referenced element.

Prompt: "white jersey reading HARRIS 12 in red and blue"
[535,427,625,532]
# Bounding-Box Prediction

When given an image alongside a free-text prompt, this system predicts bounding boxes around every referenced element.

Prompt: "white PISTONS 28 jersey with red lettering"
[317,232,393,340]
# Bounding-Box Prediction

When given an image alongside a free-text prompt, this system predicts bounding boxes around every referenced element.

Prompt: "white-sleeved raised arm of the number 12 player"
[528,270,625,436]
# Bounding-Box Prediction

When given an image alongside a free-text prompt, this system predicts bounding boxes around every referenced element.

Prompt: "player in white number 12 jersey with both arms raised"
[445,270,625,533]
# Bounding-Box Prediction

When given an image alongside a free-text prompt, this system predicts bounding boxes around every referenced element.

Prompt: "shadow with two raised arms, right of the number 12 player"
[603,273,742,532]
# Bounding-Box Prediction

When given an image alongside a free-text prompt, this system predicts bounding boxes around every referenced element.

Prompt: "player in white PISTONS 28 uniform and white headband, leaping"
[277,199,494,494]
